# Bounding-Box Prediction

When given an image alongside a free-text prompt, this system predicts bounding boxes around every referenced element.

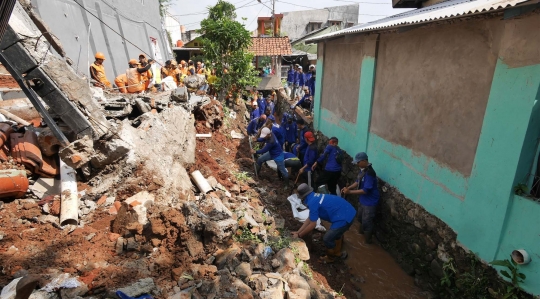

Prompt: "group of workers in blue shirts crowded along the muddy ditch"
[247,91,380,262]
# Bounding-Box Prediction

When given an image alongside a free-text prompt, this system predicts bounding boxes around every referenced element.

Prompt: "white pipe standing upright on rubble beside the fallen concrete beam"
[60,159,79,226]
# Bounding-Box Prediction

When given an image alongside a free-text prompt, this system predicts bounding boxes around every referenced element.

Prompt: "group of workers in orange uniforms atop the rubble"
[90,52,217,93]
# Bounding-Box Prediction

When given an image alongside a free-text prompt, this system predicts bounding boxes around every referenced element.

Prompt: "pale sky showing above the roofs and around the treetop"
[169,0,408,31]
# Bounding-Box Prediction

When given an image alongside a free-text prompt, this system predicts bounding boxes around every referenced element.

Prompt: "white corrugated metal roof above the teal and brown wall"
[306,0,537,42]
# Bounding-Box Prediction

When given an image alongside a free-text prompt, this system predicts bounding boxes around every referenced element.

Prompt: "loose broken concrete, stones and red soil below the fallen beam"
[0,89,346,298]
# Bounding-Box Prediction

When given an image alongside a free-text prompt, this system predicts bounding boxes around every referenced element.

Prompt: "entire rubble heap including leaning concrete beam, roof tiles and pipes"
[0,4,350,299]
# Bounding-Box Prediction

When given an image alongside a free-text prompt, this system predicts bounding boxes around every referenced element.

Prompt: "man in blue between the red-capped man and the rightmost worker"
[311,137,342,195]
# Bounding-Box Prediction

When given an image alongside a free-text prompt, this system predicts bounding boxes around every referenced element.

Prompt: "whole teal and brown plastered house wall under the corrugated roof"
[314,10,540,294]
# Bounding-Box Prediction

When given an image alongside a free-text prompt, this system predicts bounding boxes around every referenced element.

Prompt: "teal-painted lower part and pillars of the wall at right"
[315,25,540,295]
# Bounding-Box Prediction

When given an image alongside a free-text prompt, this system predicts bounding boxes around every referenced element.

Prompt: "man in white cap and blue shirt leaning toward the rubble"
[251,127,289,188]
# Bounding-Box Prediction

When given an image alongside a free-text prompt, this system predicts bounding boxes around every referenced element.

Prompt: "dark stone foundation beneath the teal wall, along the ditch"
[316,132,532,298]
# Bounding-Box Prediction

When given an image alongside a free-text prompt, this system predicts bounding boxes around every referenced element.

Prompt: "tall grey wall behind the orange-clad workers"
[32,0,170,82]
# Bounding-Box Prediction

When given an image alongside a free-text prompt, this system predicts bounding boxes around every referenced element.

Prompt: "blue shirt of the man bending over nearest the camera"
[305,192,356,229]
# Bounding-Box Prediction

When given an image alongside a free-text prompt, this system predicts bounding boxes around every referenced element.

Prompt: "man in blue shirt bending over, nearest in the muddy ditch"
[291,184,356,263]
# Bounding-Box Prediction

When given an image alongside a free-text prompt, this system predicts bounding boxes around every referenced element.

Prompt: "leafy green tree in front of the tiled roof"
[200,0,257,100]
